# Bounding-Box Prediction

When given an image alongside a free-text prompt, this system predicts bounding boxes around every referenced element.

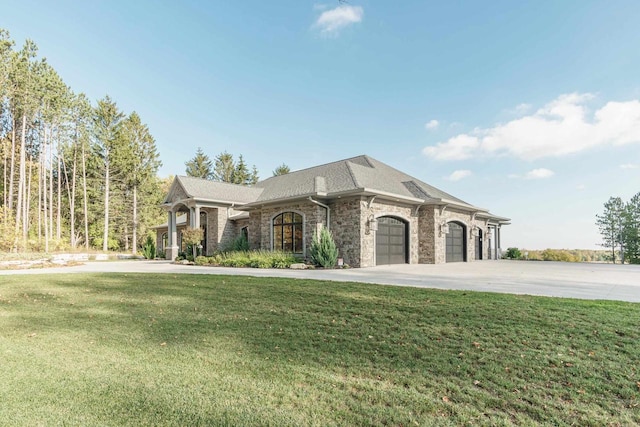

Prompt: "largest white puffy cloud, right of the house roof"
[423,93,640,160]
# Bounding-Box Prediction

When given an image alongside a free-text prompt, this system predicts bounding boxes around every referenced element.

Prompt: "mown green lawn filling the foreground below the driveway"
[0,274,640,426]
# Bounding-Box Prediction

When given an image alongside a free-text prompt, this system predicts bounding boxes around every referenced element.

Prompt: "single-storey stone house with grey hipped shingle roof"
[157,155,510,267]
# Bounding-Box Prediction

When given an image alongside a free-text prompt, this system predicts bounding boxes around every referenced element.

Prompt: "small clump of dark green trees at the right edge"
[596,193,640,264]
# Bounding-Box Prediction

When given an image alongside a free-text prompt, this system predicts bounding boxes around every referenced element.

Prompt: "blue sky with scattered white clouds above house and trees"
[0,0,640,249]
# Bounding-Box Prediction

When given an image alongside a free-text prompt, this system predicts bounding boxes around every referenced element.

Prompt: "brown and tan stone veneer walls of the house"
[157,196,496,267]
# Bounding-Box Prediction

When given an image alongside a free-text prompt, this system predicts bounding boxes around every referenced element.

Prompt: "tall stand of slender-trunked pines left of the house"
[0,29,167,253]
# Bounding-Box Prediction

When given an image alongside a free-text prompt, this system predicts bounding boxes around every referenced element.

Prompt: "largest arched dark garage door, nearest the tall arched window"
[376,216,407,265]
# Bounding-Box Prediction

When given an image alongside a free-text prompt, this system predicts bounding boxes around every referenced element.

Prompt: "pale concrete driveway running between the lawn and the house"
[0,260,640,302]
